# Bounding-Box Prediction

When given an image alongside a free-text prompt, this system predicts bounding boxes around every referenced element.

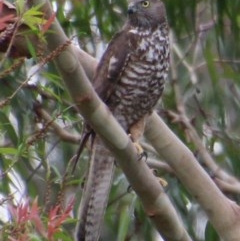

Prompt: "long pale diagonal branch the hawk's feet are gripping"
[33,0,191,241]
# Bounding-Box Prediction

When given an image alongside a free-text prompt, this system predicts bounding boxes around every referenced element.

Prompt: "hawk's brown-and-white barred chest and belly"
[111,25,169,128]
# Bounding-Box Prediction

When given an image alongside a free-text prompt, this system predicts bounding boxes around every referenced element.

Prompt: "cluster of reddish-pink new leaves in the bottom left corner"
[1,199,73,241]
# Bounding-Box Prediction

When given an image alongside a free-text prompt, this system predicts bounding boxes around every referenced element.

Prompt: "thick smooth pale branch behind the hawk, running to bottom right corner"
[145,113,240,241]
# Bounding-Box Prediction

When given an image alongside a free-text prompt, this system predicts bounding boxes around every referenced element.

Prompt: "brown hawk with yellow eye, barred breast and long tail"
[77,0,169,241]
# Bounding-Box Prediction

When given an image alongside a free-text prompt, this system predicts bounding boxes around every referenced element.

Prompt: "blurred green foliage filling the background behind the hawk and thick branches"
[0,0,240,241]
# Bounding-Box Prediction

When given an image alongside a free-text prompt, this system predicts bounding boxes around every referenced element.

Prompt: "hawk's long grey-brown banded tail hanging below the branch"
[76,137,114,241]
